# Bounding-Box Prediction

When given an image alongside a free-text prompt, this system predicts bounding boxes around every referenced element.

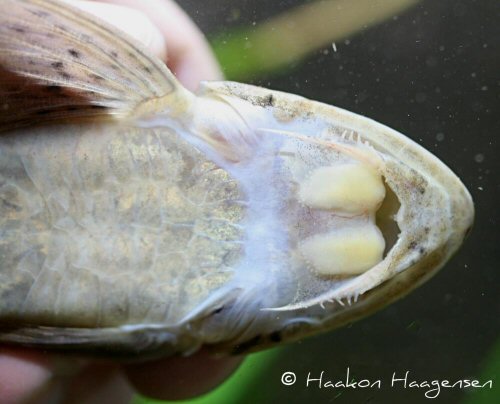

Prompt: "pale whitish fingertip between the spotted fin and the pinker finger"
[66,0,167,60]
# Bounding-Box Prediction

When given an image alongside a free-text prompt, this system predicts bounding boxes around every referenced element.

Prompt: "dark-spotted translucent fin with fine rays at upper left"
[0,0,180,131]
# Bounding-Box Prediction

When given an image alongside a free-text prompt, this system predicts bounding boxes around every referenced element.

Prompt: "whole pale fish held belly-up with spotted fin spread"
[0,0,474,358]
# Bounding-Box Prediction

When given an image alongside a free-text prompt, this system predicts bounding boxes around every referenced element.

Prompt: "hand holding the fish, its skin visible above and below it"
[0,0,241,404]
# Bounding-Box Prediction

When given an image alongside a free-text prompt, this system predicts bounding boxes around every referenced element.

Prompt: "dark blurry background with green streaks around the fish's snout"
[137,0,500,404]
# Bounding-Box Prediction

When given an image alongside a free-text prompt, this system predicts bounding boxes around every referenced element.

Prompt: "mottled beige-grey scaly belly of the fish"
[0,125,243,328]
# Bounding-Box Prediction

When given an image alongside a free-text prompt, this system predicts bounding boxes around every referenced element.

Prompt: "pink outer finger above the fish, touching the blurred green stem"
[95,0,222,90]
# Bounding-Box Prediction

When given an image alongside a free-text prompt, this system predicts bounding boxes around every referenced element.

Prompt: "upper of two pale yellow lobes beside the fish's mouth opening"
[299,163,385,214]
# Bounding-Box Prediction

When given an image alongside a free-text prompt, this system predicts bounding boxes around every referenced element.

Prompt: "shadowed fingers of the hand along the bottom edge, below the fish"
[0,347,241,404]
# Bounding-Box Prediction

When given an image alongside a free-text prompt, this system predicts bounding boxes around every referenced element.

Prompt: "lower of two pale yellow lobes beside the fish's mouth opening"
[299,223,385,275]
